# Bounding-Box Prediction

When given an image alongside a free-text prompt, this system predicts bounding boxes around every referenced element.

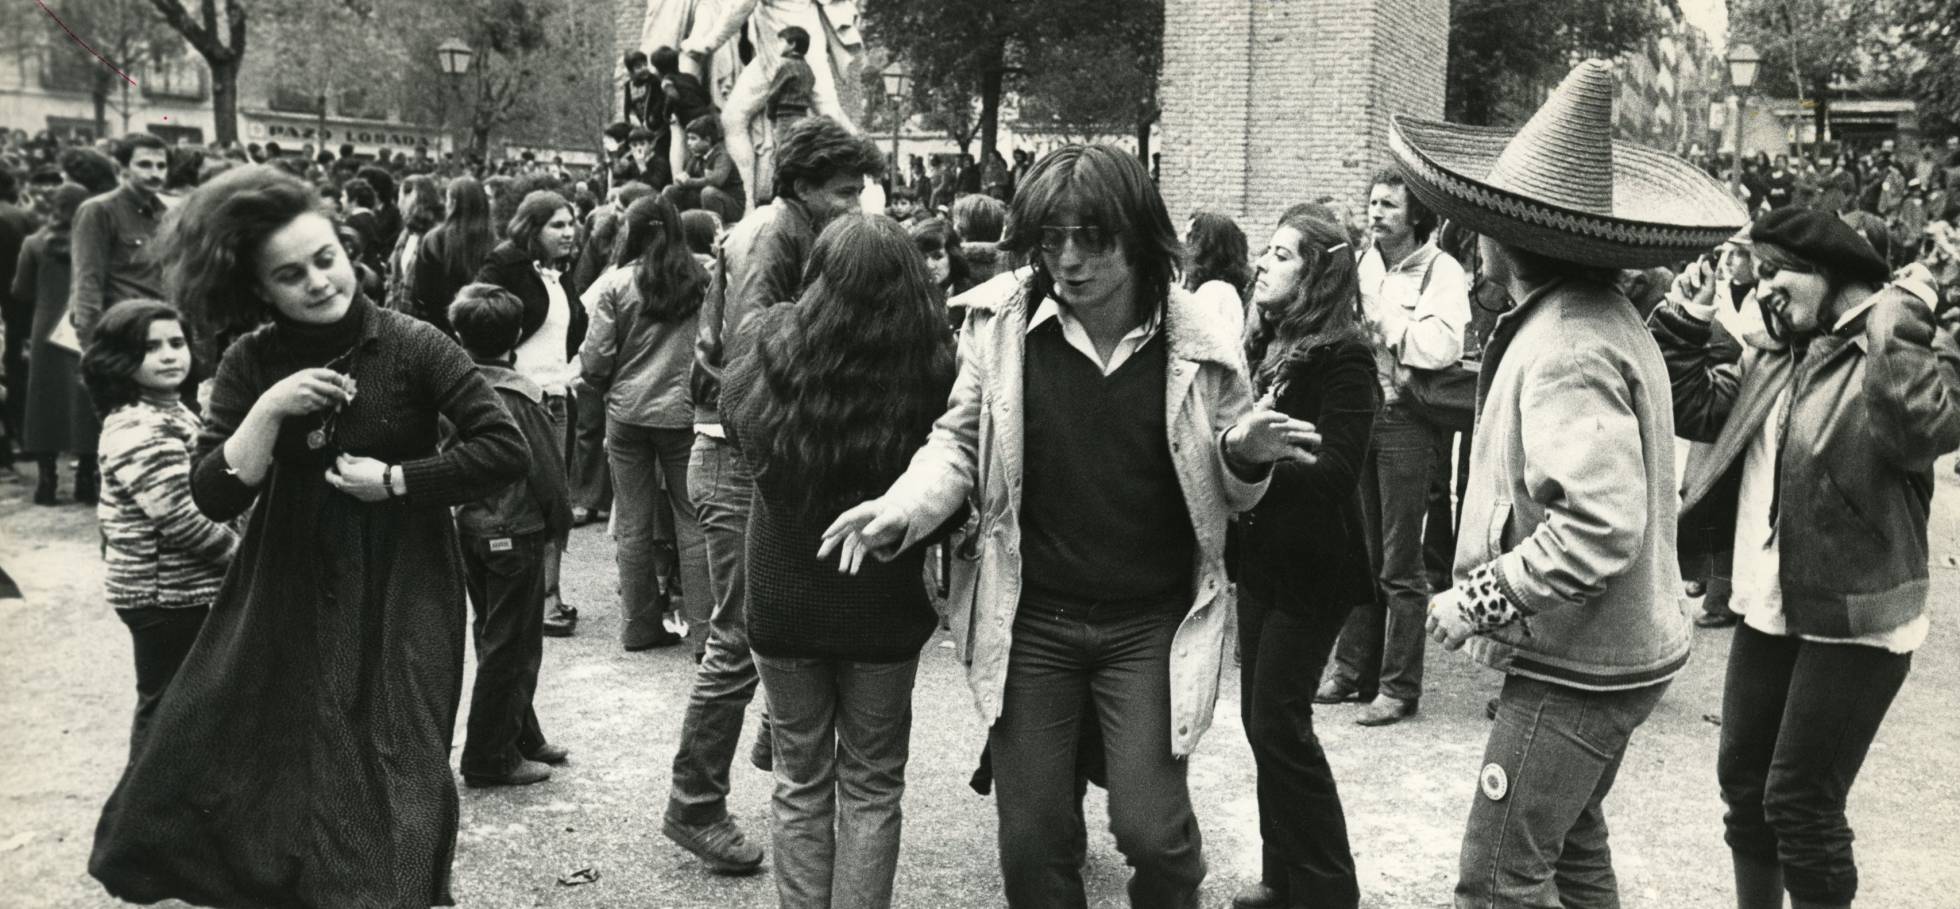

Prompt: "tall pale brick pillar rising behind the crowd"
[1158,0,1448,231]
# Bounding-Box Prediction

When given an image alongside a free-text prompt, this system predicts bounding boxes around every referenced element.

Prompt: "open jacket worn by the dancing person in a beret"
[1652,286,1960,639]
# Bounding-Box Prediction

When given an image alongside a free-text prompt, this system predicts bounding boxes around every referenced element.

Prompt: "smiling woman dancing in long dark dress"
[88,167,525,907]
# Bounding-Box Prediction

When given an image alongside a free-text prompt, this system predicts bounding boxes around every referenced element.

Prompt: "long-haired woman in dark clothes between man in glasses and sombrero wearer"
[1233,207,1380,909]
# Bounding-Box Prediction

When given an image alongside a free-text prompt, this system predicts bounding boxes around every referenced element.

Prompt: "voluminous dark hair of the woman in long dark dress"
[157,165,319,356]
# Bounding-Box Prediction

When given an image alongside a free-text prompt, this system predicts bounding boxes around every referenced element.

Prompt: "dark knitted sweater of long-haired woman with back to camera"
[721,306,964,662]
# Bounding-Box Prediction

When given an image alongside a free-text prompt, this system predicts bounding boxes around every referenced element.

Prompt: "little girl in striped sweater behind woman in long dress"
[82,300,237,754]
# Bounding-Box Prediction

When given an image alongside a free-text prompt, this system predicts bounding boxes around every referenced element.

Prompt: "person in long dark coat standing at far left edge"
[12,182,100,505]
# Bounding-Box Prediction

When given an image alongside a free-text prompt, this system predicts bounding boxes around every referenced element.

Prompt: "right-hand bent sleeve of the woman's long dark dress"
[402,331,529,505]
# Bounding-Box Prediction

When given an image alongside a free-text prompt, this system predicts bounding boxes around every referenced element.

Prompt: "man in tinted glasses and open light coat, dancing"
[819,145,1319,907]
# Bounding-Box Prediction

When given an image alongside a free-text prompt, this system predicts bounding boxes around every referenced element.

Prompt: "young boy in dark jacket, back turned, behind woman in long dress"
[449,284,572,786]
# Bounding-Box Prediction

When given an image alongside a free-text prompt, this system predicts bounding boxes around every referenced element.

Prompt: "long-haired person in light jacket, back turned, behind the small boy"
[578,196,713,650]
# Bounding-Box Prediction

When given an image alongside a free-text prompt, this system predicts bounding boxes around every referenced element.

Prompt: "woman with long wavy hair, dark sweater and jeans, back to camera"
[721,215,958,909]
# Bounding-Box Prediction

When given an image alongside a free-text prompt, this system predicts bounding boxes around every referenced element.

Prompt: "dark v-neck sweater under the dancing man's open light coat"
[1021,321,1198,607]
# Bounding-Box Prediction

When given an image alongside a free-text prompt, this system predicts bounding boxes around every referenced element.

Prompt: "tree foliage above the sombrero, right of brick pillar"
[1443,0,1662,125]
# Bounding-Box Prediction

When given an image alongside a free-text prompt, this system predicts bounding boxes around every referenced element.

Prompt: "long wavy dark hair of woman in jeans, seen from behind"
[757,208,956,519]
